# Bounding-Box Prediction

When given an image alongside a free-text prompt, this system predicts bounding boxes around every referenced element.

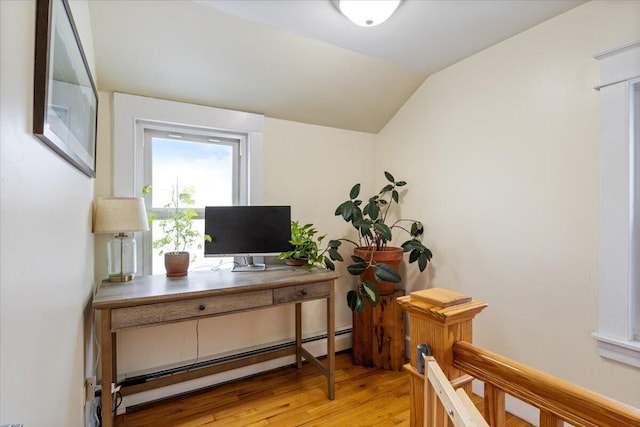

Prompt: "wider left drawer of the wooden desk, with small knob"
[111,289,273,331]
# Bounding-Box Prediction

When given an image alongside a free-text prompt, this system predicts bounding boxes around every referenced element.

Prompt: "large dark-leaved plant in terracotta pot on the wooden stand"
[325,172,433,312]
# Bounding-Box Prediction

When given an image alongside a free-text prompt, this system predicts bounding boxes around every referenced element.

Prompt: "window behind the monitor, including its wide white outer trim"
[112,92,264,274]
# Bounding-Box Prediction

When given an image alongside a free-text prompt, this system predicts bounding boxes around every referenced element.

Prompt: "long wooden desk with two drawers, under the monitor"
[93,268,339,427]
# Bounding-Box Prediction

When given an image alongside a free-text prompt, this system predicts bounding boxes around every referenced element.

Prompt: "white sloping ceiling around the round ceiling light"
[89,0,584,132]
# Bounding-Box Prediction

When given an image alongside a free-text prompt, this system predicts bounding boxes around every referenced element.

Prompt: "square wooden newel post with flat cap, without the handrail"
[397,288,487,427]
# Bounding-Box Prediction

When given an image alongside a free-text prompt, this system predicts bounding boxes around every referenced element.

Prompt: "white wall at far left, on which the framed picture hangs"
[0,1,94,427]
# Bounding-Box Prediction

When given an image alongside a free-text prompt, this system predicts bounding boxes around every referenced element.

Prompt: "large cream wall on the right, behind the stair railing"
[377,1,640,407]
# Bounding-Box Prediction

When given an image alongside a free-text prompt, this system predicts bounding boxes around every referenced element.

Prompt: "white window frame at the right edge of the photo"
[592,40,640,368]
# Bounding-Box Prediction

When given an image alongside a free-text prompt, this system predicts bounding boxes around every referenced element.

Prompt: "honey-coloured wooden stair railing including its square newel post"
[397,288,640,427]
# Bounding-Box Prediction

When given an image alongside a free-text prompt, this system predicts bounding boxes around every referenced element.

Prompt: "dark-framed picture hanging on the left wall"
[33,0,98,177]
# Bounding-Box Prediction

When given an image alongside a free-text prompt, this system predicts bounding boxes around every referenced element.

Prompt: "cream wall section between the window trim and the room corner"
[264,119,377,328]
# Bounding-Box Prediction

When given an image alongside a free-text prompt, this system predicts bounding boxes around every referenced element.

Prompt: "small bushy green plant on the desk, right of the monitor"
[278,221,326,269]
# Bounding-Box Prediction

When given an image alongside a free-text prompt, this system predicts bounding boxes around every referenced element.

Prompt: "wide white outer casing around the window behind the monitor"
[112,92,264,274]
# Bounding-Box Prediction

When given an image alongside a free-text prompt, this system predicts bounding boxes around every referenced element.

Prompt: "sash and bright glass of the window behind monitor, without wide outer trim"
[143,124,246,274]
